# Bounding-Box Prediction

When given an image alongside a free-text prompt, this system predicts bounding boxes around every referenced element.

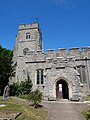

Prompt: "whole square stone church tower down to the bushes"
[13,22,42,82]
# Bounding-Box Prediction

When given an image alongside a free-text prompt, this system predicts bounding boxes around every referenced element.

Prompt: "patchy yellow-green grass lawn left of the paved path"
[0,97,48,120]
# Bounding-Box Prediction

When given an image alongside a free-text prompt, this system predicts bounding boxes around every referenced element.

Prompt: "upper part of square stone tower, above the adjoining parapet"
[16,22,42,56]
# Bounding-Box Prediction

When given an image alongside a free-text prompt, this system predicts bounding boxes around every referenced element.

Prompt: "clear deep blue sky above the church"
[0,0,90,51]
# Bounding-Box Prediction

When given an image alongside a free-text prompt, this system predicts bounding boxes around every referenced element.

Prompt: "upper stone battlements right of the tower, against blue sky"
[46,47,90,59]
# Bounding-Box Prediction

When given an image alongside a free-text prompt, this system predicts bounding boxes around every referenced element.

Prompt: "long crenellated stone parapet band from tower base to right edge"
[24,47,90,65]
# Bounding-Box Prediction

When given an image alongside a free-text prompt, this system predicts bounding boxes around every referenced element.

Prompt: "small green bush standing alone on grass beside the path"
[28,90,42,108]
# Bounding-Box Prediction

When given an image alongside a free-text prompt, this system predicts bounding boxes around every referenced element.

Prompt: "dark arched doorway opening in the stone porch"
[56,80,69,99]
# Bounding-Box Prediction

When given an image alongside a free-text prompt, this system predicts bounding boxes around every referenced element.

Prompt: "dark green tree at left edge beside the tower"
[0,45,13,95]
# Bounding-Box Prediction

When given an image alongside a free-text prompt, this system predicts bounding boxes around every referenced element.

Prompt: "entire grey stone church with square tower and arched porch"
[13,22,90,100]
